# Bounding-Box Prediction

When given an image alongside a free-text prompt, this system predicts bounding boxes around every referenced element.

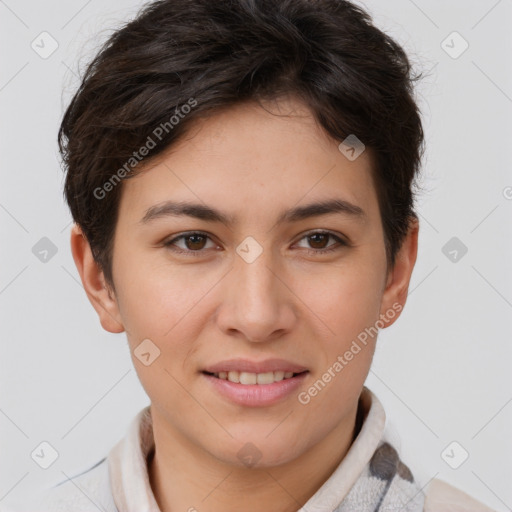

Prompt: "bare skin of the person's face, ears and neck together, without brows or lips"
[71,98,418,512]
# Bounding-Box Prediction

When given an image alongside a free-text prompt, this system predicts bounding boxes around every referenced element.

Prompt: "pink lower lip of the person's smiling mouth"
[202,372,309,407]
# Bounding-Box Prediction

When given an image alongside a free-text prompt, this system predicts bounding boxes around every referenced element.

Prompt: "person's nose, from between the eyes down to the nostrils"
[217,241,297,342]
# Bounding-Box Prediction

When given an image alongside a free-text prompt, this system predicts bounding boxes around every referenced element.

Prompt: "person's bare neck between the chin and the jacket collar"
[148,408,362,512]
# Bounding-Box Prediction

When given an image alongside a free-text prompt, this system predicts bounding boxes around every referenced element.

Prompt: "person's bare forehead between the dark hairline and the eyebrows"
[120,100,378,225]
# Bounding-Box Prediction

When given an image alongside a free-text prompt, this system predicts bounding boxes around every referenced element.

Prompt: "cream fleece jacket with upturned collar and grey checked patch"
[16,387,493,512]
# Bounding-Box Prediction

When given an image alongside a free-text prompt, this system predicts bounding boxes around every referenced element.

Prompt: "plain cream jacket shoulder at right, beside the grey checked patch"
[424,478,494,512]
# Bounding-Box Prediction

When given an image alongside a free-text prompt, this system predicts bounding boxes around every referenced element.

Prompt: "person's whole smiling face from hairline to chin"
[75,94,414,466]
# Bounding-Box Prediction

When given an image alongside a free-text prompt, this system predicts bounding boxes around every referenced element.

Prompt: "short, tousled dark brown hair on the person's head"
[58,0,423,287]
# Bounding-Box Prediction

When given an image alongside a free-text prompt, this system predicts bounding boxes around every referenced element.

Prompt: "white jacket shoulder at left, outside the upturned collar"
[32,458,118,512]
